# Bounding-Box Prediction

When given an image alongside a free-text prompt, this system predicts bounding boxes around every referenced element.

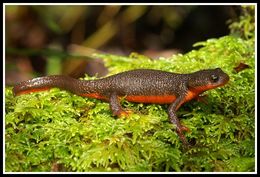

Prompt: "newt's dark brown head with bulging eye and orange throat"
[188,68,229,93]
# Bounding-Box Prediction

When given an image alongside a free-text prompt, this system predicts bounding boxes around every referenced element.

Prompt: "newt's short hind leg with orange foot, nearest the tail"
[109,92,129,117]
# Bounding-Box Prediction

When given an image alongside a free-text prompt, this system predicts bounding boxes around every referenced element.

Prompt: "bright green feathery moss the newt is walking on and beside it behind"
[5,5,255,172]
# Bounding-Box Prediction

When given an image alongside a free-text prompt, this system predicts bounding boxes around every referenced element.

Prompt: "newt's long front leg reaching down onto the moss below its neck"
[168,96,189,145]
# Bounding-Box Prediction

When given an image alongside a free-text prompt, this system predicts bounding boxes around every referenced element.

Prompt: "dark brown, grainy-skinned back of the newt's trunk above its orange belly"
[99,69,186,96]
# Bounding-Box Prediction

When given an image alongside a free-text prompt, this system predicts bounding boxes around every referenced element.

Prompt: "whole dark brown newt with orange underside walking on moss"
[13,68,229,144]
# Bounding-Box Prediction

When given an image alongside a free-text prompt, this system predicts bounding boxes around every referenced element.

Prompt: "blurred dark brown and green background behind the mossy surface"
[5,5,241,86]
